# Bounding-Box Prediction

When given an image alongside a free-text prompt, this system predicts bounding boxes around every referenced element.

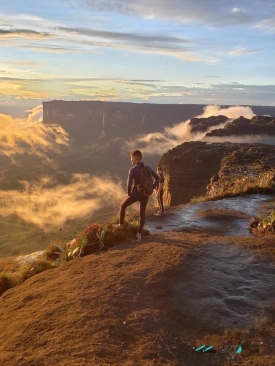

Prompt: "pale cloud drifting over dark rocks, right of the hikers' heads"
[128,105,254,155]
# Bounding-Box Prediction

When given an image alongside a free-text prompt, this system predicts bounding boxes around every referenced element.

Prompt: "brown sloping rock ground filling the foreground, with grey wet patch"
[0,232,275,366]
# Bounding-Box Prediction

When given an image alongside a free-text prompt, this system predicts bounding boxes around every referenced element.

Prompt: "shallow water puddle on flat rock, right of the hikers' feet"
[148,195,273,236]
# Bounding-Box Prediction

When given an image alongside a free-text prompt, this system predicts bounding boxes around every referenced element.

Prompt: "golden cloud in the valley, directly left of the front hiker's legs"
[0,174,125,231]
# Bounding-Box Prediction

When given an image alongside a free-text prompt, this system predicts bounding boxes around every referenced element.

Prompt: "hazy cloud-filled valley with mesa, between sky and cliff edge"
[0,101,275,256]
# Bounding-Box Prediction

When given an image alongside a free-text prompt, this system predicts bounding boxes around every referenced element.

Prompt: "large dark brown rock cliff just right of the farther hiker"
[158,142,275,206]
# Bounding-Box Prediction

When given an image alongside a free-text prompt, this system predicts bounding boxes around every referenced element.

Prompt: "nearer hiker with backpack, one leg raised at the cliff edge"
[113,150,159,241]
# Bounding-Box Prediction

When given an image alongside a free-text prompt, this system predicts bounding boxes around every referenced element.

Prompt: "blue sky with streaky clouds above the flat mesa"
[0,0,275,117]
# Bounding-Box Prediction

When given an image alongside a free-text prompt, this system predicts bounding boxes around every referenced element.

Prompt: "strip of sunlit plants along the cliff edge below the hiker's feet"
[0,217,150,295]
